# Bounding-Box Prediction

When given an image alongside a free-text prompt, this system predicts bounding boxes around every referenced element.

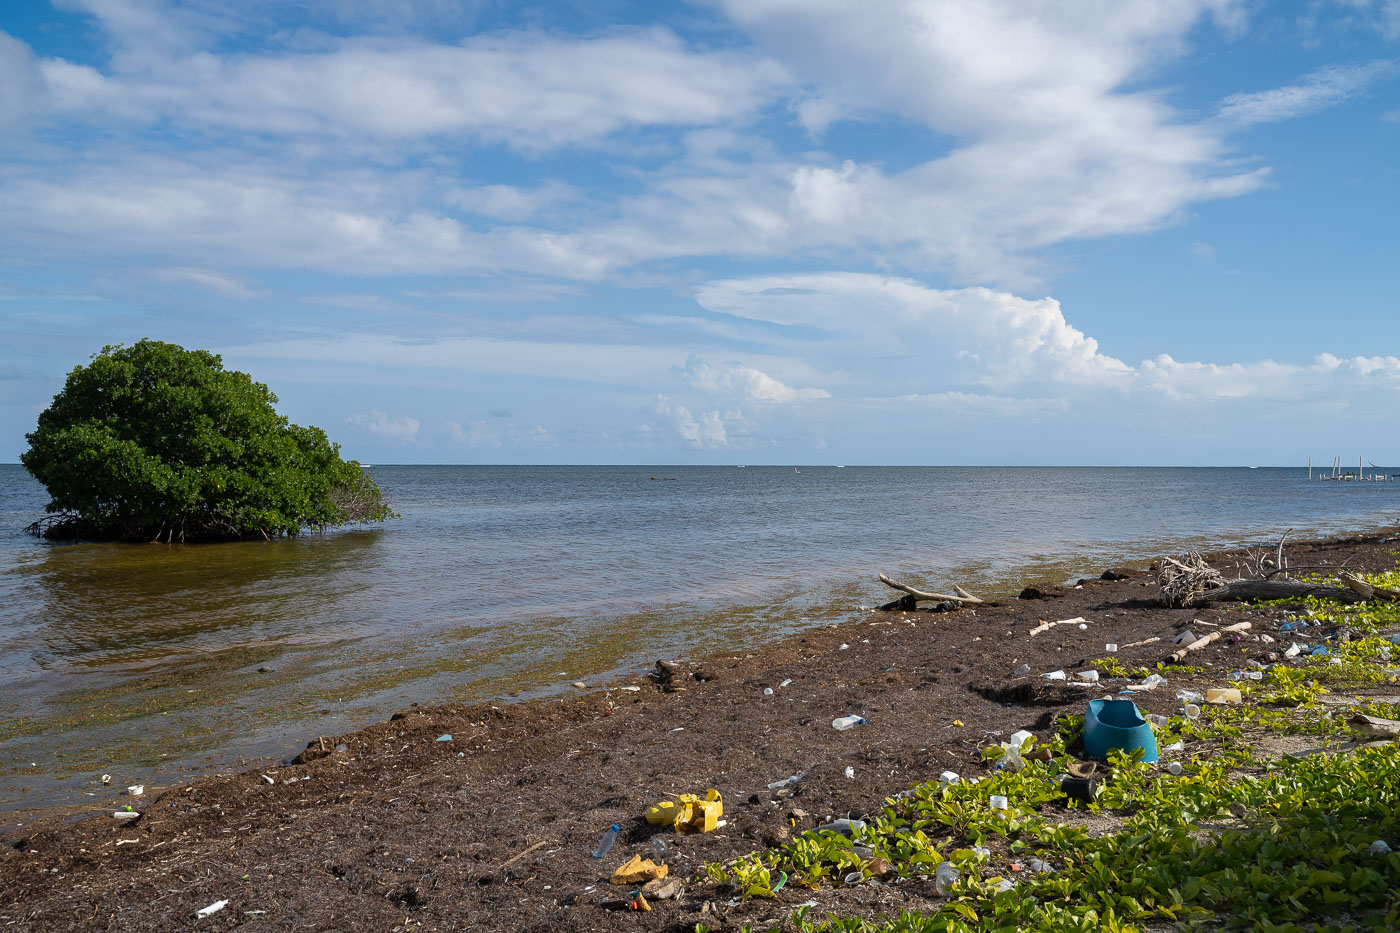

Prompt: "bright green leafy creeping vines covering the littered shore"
[696,573,1400,933]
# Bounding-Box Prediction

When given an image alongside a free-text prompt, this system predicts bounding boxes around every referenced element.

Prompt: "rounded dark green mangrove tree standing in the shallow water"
[20,340,395,541]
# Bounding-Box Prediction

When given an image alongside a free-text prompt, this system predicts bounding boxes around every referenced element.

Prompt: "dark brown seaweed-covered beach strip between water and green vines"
[0,530,1400,930]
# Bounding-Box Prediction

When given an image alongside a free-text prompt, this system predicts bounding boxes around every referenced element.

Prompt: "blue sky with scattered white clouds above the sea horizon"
[0,0,1400,465]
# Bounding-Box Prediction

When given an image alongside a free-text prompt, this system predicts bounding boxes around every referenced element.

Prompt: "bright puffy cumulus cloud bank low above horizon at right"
[696,273,1400,415]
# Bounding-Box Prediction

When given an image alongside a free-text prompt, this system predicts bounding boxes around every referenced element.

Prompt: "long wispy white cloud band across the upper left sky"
[41,28,785,150]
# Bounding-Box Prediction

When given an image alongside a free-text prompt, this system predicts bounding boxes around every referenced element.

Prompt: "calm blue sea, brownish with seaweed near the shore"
[0,465,1400,811]
